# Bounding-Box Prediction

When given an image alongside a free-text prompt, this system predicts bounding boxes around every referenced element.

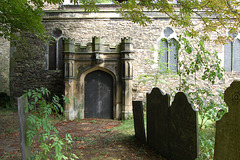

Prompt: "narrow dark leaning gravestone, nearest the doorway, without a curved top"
[133,101,146,143]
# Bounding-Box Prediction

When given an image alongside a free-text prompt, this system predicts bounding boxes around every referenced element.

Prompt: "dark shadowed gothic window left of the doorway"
[48,29,63,70]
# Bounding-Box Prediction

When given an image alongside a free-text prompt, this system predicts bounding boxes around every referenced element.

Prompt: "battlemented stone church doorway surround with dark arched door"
[63,37,133,120]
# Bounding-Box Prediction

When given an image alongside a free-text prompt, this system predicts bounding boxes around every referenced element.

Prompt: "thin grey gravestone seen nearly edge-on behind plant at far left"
[18,95,31,160]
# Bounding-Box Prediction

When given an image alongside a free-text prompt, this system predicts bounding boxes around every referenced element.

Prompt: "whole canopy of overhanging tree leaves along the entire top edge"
[0,0,240,43]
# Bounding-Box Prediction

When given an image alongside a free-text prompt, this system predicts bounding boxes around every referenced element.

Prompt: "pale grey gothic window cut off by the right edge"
[224,37,240,72]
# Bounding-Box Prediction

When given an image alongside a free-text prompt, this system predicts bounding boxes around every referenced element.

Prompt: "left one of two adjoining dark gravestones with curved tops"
[147,88,170,157]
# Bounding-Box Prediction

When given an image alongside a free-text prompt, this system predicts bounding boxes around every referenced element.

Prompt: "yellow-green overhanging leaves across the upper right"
[115,0,240,43]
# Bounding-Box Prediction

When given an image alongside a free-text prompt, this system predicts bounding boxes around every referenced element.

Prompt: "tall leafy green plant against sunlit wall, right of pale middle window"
[177,33,226,125]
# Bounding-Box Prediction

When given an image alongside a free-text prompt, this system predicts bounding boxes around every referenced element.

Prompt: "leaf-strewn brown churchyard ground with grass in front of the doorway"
[0,109,162,160]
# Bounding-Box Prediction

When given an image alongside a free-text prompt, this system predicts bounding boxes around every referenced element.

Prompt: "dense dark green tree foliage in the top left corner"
[0,0,52,39]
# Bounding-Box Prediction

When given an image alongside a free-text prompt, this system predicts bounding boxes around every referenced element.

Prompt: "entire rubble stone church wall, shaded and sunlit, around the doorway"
[3,6,240,105]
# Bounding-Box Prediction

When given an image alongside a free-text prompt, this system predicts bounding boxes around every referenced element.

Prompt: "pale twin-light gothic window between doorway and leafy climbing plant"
[159,27,178,72]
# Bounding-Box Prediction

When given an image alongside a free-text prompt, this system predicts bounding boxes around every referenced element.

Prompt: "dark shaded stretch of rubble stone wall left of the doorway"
[10,34,64,98]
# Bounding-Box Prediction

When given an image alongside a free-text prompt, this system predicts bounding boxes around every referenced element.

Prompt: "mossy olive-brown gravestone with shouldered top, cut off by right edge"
[214,80,240,160]
